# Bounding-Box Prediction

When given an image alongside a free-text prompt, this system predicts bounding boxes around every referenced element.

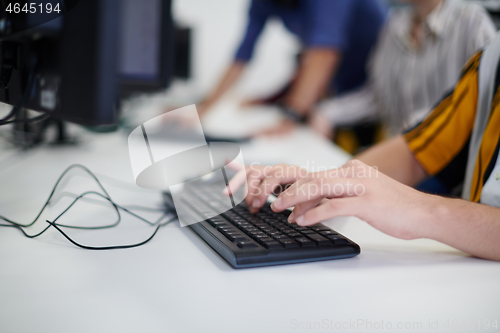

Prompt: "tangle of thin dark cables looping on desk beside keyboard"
[0,164,180,250]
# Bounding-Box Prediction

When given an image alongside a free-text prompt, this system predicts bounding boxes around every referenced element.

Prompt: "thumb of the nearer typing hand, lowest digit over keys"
[295,197,367,226]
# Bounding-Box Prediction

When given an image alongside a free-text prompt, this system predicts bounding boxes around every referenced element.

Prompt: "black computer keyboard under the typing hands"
[164,185,360,268]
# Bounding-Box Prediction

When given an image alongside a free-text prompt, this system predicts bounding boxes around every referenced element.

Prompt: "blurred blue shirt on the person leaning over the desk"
[236,0,386,93]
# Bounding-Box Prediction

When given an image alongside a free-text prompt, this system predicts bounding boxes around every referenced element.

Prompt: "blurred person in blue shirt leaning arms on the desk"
[197,0,386,134]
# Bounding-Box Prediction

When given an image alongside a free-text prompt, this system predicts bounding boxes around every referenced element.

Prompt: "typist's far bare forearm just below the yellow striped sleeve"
[354,136,427,186]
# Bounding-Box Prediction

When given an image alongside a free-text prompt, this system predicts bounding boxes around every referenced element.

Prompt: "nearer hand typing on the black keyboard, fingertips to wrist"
[271,160,440,239]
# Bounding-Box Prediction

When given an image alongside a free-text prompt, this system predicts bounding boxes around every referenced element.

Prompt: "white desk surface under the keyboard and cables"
[0,107,500,333]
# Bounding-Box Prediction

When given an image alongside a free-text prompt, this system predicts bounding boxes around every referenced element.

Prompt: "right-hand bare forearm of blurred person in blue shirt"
[285,48,340,114]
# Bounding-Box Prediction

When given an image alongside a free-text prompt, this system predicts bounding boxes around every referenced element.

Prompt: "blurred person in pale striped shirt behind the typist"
[310,0,496,138]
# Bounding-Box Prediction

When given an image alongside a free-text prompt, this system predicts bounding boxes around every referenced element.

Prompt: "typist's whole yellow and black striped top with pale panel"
[404,34,500,207]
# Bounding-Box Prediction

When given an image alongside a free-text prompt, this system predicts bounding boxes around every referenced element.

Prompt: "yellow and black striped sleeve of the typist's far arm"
[403,51,482,189]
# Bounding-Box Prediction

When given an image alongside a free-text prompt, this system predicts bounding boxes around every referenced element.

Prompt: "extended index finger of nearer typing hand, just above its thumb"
[271,178,365,211]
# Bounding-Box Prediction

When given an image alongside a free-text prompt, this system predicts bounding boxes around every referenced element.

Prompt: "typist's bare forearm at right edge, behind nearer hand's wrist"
[420,196,500,260]
